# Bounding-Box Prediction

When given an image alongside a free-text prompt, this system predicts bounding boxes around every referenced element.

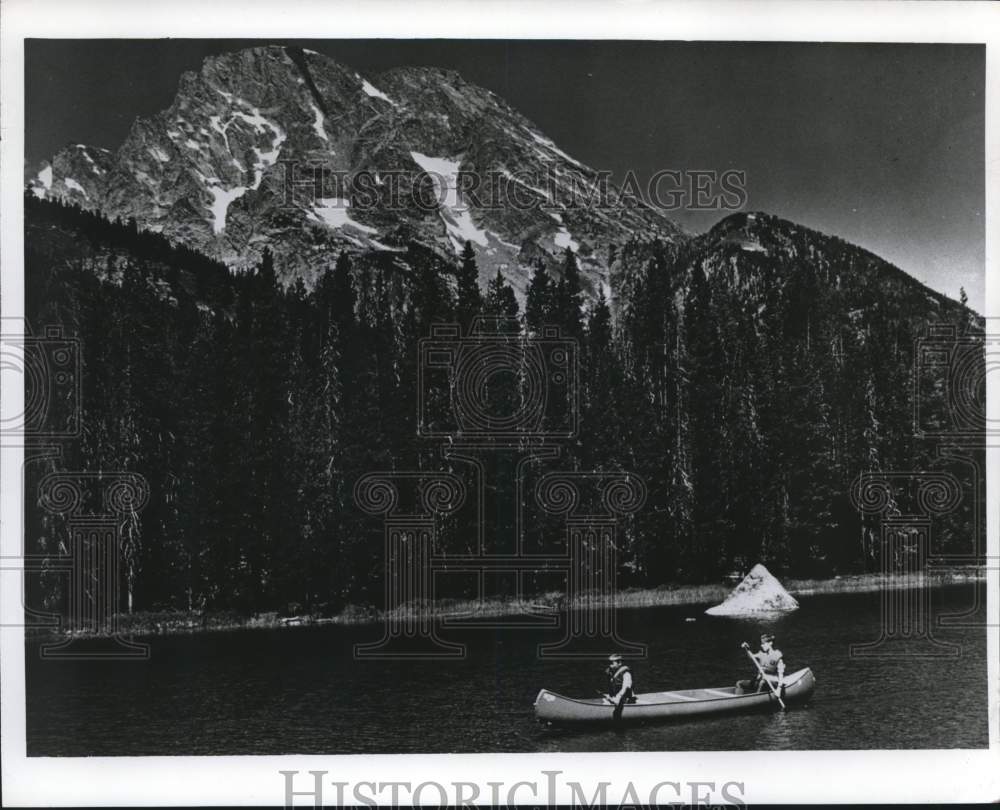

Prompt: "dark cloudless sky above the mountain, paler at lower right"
[25,40,985,311]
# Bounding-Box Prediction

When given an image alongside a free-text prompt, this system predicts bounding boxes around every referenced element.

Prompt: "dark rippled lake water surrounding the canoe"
[26,585,995,756]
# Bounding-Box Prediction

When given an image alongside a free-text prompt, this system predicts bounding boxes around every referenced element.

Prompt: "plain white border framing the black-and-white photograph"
[0,0,1000,806]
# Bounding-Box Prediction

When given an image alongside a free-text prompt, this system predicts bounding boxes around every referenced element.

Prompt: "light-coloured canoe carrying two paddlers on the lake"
[535,667,816,725]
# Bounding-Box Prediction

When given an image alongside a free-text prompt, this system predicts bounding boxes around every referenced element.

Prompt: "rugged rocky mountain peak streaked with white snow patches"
[29,46,683,293]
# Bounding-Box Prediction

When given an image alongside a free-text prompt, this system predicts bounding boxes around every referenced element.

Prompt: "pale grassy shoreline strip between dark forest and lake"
[25,566,986,638]
